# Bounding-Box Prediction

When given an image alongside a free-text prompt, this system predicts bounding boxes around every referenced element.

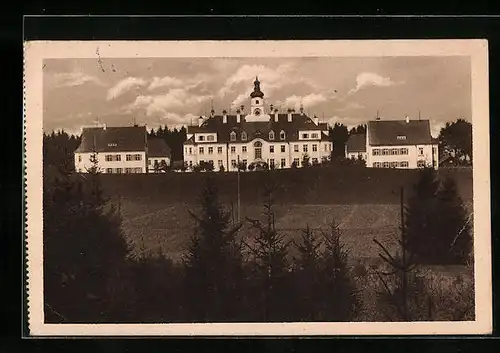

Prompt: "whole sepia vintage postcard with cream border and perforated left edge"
[24,40,492,336]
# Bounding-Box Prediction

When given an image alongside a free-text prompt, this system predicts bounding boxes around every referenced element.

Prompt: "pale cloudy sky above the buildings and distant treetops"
[43,57,471,133]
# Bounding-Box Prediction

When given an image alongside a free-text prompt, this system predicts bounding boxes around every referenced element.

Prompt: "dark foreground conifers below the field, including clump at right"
[43,147,472,322]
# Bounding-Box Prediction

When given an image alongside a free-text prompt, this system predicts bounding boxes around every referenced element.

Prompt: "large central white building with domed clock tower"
[184,78,333,171]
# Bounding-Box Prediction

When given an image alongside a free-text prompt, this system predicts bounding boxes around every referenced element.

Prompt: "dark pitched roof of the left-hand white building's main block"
[75,126,146,153]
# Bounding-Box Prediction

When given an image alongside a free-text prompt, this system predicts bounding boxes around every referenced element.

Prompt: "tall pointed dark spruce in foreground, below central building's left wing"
[184,178,243,322]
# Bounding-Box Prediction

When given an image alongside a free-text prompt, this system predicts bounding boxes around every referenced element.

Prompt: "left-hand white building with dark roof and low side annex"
[75,125,170,174]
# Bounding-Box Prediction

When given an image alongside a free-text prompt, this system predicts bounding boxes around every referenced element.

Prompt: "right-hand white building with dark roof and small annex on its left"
[346,118,439,169]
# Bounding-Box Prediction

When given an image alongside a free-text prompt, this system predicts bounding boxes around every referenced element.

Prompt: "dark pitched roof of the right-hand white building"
[368,120,433,146]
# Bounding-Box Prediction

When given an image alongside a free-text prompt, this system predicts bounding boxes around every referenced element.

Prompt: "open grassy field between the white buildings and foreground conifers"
[103,168,472,260]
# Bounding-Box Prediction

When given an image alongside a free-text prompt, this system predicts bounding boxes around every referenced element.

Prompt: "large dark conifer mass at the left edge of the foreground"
[43,151,128,322]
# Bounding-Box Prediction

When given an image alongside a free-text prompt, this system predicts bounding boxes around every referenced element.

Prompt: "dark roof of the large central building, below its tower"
[186,114,328,144]
